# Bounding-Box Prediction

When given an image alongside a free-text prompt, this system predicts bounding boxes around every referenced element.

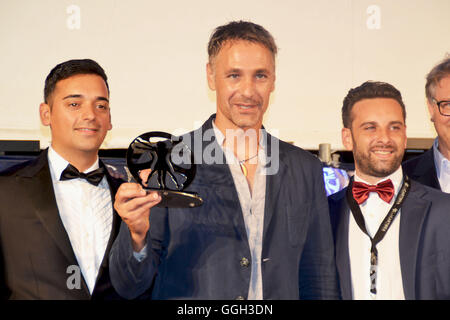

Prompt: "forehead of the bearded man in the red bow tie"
[351,98,404,124]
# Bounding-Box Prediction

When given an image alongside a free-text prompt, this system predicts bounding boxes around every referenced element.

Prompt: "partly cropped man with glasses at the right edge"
[403,57,450,193]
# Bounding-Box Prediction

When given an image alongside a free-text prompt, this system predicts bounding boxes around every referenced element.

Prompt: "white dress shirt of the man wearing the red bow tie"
[348,167,405,300]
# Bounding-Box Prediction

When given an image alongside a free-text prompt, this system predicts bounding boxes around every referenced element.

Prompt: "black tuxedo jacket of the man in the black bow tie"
[0,150,120,300]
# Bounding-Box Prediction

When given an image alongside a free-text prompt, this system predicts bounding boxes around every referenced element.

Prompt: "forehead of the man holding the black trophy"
[212,40,275,70]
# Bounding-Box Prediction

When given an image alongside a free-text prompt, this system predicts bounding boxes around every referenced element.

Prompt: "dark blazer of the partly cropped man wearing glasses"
[402,148,441,190]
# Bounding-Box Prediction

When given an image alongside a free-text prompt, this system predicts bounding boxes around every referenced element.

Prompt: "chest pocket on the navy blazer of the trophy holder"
[285,203,310,247]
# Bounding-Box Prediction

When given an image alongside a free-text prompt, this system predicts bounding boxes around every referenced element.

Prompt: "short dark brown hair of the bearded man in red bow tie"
[342,81,406,128]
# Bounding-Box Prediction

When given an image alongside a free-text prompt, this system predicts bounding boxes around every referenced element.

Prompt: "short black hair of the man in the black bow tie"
[44,59,109,103]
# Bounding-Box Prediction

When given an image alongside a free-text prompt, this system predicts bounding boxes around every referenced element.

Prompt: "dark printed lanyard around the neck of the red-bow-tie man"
[346,175,411,294]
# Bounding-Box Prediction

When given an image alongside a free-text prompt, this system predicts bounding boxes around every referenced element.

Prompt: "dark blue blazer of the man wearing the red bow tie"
[328,181,450,300]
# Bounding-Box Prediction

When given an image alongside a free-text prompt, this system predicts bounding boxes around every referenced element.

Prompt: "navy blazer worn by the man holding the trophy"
[110,115,338,299]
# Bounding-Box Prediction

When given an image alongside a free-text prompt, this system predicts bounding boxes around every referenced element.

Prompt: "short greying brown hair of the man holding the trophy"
[208,20,278,62]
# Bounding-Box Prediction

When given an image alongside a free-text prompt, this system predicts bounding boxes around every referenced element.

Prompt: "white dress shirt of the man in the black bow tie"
[48,147,113,294]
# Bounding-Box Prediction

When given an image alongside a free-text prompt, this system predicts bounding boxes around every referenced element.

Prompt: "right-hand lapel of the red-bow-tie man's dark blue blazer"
[399,181,431,300]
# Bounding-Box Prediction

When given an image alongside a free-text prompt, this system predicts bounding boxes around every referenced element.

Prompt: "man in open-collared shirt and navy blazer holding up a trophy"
[110,21,338,299]
